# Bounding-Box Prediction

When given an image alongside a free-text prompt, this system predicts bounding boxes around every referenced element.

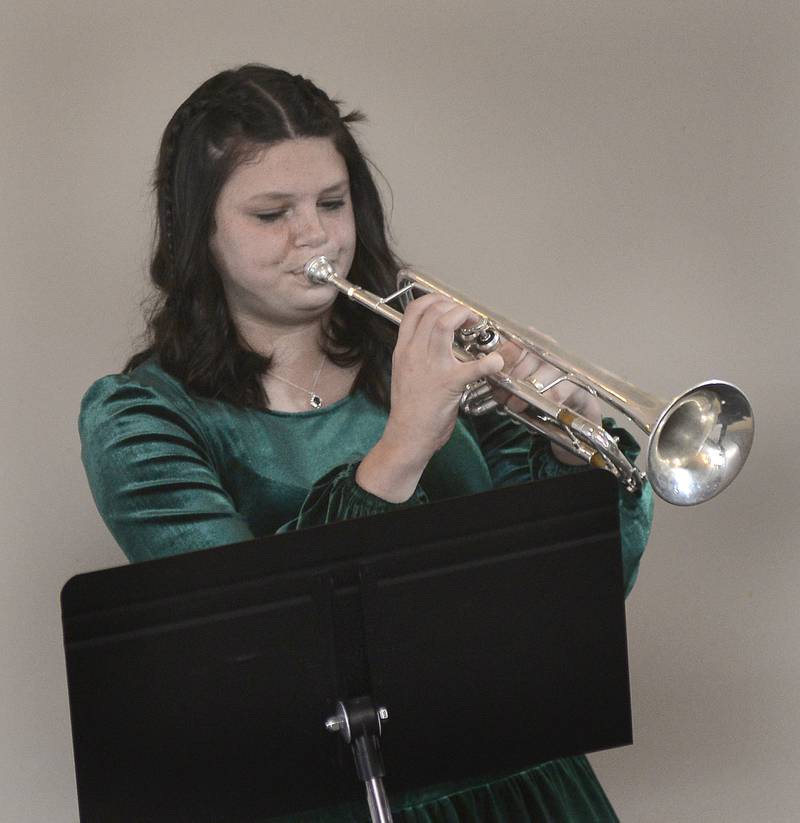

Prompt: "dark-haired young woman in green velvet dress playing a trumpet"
[80,65,652,821]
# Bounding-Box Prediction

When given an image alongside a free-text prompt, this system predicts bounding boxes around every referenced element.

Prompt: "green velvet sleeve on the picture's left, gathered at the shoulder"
[79,376,253,561]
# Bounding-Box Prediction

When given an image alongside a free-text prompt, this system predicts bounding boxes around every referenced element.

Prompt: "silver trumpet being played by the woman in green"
[304,256,754,506]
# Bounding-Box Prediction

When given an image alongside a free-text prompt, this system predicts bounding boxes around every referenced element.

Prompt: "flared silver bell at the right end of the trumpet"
[647,380,755,506]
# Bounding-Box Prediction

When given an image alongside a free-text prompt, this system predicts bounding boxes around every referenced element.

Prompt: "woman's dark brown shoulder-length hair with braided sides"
[125,63,400,408]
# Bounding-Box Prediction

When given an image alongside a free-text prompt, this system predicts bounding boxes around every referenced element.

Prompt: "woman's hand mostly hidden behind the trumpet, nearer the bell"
[494,334,602,465]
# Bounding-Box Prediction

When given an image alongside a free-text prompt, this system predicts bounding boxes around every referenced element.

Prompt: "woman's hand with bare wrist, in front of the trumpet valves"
[356,294,503,503]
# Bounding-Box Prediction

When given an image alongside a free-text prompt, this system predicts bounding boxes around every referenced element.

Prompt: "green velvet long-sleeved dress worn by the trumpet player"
[80,361,652,823]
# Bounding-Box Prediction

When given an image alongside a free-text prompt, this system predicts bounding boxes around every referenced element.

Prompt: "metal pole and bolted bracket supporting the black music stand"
[325,697,392,823]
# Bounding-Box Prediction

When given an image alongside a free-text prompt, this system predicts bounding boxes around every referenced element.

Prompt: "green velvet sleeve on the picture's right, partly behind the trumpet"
[471,414,653,597]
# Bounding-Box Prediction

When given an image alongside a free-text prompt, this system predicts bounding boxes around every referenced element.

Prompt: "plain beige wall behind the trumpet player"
[0,0,800,823]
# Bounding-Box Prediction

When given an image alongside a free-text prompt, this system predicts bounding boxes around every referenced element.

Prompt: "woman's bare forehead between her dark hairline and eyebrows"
[220,137,348,199]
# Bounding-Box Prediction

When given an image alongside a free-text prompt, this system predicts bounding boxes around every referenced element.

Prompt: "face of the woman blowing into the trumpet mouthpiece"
[209,137,356,330]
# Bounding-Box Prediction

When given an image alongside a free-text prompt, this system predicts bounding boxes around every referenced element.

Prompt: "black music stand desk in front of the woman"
[62,471,631,823]
